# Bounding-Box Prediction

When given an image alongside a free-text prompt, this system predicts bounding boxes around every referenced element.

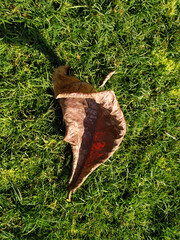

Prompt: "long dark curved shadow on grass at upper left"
[0,19,63,67]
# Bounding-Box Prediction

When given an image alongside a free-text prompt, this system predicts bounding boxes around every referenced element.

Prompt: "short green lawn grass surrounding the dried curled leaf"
[0,0,180,240]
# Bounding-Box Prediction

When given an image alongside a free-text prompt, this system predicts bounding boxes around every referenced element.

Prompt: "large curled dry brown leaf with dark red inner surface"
[52,66,126,200]
